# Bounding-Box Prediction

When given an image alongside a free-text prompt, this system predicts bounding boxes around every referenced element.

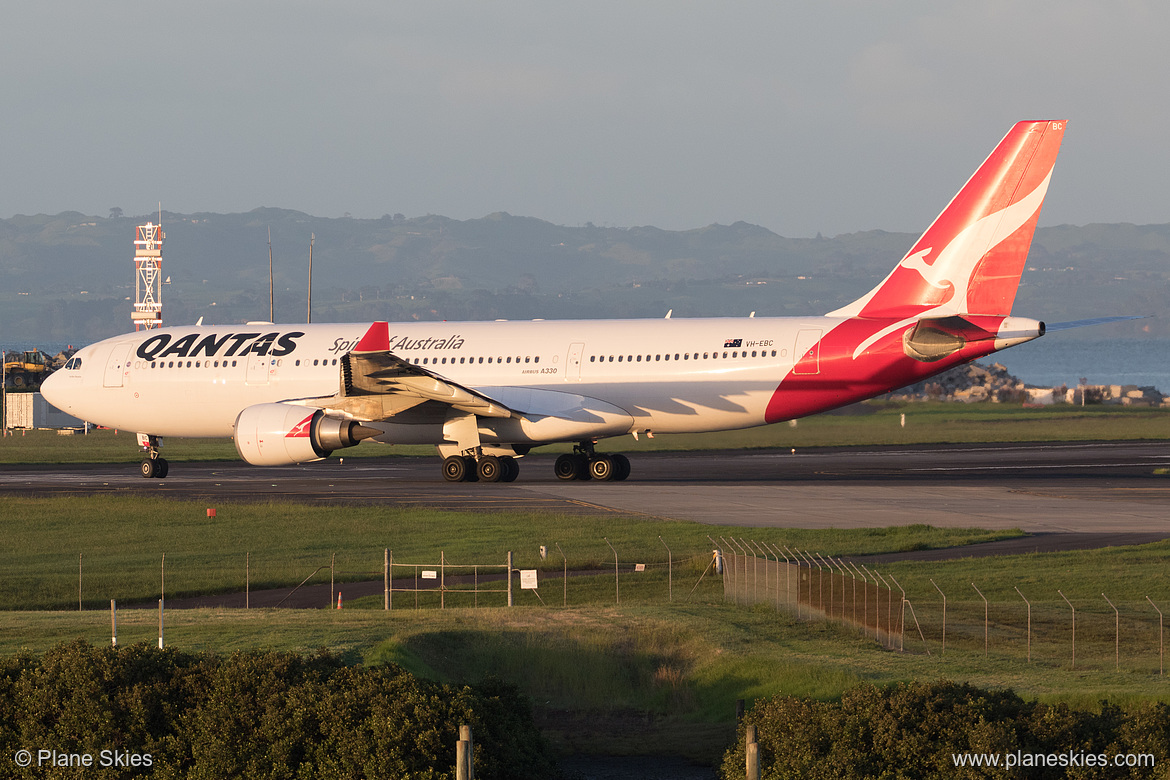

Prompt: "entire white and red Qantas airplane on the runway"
[41,120,1113,482]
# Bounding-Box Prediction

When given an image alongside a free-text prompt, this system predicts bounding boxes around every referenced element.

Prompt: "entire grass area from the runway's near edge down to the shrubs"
[11,496,1170,760]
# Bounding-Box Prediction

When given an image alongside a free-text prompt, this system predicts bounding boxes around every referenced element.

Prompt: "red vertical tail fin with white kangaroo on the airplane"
[828,119,1066,319]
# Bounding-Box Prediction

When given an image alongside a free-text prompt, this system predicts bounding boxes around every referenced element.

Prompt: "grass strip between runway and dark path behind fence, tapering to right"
[0,496,1019,609]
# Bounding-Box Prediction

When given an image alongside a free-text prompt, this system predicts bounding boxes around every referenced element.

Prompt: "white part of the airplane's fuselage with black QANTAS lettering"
[36,317,823,443]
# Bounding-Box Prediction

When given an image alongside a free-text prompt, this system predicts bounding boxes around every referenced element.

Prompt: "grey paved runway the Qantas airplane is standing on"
[0,442,1170,537]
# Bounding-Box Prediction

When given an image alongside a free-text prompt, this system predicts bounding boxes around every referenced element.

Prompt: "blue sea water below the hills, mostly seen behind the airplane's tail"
[5,339,1170,394]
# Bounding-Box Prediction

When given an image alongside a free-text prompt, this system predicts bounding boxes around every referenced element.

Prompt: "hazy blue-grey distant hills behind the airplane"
[0,208,1170,344]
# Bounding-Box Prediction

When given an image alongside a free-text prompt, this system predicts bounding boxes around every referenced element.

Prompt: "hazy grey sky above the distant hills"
[0,0,1170,236]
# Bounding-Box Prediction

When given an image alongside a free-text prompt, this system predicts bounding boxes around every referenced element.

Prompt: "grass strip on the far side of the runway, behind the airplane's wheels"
[0,402,1170,463]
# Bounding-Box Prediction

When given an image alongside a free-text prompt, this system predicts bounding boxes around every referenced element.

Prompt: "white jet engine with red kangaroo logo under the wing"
[235,403,381,465]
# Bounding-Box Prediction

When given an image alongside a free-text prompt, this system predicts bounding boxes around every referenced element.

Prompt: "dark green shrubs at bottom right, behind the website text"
[722,681,1170,780]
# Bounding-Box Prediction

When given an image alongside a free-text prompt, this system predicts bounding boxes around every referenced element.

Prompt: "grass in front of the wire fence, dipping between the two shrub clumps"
[9,584,1170,760]
